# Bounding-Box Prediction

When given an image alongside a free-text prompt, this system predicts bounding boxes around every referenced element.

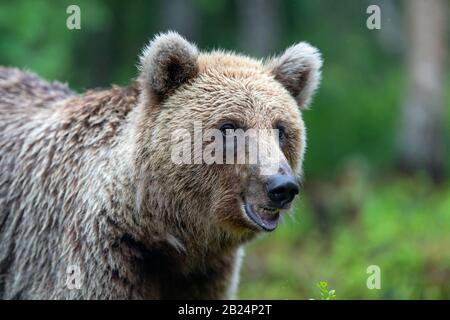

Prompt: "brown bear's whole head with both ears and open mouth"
[136,33,322,246]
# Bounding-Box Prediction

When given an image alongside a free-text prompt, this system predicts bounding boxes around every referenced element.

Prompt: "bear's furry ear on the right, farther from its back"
[267,42,322,108]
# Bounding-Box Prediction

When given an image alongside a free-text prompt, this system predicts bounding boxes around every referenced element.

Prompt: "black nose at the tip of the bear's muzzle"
[267,174,299,209]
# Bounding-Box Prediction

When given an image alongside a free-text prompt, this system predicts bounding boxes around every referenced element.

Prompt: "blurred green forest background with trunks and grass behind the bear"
[0,0,450,299]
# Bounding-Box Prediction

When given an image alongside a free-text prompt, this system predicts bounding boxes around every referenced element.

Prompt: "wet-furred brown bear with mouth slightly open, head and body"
[0,32,322,299]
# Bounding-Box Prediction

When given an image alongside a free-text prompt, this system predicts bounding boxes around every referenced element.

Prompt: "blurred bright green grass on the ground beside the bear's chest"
[239,176,450,299]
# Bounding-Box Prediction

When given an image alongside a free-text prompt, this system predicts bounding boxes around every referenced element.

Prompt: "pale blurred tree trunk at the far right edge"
[399,0,448,182]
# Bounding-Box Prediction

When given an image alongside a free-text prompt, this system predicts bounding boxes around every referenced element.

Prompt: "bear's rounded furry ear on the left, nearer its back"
[139,31,198,100]
